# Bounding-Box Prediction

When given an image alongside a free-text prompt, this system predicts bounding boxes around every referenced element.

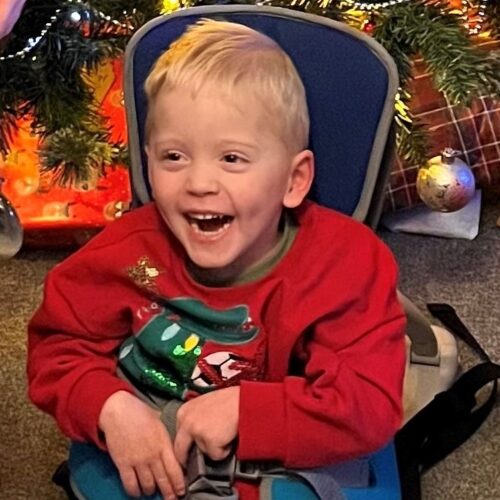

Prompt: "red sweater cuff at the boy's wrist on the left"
[68,370,134,450]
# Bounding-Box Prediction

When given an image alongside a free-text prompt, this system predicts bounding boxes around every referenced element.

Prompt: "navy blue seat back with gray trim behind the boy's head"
[125,5,398,221]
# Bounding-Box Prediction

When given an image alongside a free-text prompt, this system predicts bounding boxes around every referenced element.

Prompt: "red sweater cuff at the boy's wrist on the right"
[237,381,287,462]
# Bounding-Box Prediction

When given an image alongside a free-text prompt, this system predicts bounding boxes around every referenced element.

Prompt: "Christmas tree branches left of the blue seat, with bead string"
[0,0,161,184]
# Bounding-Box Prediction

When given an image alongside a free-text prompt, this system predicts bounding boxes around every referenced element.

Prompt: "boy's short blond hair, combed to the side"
[144,19,309,151]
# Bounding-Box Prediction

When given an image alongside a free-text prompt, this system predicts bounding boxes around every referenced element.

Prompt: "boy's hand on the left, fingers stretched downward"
[99,391,185,499]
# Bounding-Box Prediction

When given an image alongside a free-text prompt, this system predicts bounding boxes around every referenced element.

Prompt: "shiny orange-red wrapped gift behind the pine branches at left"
[0,59,131,247]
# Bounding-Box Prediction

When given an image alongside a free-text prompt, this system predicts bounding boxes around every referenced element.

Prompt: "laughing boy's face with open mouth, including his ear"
[146,85,313,277]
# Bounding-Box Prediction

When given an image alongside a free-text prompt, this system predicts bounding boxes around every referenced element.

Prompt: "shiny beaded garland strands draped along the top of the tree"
[0,0,488,62]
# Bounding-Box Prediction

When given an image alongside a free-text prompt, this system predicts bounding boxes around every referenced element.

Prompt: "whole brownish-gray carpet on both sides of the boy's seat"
[0,193,500,500]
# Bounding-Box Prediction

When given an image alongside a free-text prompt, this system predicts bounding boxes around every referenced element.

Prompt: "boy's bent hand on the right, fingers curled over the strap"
[174,387,240,465]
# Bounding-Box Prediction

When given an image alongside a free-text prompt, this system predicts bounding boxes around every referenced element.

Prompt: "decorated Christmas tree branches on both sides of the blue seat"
[0,0,500,183]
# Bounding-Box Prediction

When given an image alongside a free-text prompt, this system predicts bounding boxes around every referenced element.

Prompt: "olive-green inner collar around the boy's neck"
[186,211,297,287]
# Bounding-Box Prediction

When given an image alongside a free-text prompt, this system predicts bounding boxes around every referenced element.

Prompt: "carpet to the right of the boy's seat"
[379,194,500,500]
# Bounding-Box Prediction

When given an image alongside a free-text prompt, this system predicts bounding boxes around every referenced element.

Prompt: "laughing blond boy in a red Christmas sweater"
[28,20,405,500]
